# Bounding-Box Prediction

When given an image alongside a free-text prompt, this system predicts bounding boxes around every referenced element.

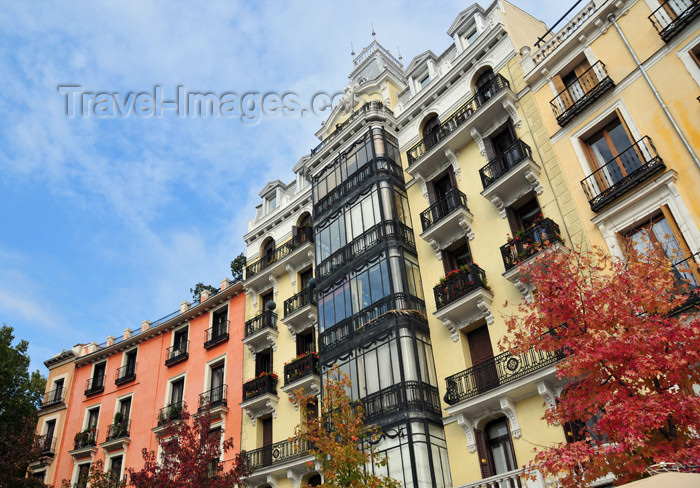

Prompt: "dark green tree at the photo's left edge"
[0,324,46,488]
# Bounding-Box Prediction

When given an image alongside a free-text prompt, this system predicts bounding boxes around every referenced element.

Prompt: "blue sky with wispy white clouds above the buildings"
[0,0,573,374]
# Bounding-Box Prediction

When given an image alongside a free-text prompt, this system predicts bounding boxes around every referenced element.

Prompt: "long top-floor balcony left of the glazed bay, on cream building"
[245,227,314,289]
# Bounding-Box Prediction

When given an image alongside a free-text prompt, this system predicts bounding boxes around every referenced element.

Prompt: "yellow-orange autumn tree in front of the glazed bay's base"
[290,367,401,488]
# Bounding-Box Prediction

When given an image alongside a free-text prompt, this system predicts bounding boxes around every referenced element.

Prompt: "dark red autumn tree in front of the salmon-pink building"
[129,409,249,488]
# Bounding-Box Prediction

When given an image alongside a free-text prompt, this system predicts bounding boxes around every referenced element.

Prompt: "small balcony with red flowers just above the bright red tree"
[501,214,566,298]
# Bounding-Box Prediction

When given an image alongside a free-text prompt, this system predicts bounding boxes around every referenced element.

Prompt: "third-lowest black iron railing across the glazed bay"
[316,220,416,280]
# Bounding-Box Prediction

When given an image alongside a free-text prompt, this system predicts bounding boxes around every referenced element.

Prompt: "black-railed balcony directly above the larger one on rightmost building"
[549,61,615,127]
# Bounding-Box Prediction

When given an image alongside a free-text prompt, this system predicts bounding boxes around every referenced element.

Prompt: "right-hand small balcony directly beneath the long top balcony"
[479,140,542,219]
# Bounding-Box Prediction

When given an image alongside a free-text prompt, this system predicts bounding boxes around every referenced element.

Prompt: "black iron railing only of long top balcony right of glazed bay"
[406,74,510,165]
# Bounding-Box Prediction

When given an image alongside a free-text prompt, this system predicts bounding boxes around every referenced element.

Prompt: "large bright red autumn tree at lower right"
[503,246,700,487]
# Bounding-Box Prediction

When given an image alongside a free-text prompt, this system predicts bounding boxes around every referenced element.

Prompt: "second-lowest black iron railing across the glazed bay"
[318,293,425,352]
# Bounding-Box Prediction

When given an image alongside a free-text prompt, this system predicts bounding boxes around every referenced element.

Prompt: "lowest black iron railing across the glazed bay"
[361,381,440,422]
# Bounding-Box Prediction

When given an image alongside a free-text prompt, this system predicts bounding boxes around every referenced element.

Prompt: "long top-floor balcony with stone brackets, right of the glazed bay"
[406,75,519,180]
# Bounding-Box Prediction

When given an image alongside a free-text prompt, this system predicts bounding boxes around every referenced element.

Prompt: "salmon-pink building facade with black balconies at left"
[30,280,244,488]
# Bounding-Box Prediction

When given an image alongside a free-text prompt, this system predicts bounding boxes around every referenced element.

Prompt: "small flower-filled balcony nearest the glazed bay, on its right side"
[433,263,493,342]
